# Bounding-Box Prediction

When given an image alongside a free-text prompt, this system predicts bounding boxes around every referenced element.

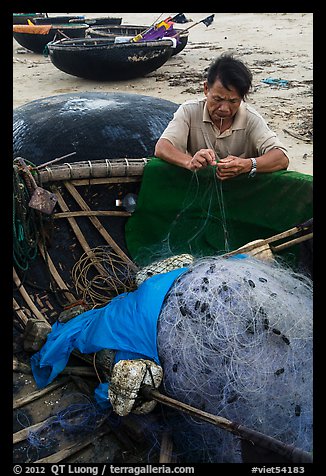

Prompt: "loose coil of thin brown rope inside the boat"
[71,246,136,307]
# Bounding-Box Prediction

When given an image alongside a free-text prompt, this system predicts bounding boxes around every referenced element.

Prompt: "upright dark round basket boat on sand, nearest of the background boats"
[48,37,173,81]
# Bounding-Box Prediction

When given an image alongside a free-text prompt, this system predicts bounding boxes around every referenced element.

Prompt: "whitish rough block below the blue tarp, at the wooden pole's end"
[109,359,163,416]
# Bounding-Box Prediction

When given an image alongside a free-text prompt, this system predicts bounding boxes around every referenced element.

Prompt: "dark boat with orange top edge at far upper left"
[13,23,89,53]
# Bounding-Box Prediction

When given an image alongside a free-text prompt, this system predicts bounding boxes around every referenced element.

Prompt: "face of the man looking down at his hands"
[204,80,242,124]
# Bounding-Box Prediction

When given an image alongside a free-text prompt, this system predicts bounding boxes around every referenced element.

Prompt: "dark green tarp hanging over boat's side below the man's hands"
[125,157,313,266]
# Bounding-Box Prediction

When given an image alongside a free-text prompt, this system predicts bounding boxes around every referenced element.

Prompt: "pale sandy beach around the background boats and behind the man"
[13,12,313,175]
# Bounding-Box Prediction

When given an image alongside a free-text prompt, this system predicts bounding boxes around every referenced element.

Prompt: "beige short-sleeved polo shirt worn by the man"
[161,98,288,159]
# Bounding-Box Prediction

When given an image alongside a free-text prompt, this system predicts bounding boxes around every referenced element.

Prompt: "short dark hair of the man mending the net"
[207,53,252,98]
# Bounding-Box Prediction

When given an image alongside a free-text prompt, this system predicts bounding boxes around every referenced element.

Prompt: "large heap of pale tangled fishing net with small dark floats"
[158,257,312,463]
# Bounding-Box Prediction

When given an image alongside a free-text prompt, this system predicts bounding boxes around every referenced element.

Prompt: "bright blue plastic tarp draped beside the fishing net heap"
[31,268,188,406]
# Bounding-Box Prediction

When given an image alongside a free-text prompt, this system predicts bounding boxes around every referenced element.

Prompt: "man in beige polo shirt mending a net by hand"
[155,53,289,180]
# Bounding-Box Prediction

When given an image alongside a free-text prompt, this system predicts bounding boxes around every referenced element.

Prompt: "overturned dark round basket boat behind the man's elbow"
[13,92,178,165]
